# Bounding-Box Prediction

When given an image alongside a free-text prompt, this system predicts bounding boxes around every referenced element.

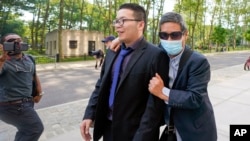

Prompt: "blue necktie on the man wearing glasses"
[109,48,133,107]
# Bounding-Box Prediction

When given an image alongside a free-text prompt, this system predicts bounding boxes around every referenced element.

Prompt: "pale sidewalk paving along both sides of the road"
[0,61,250,141]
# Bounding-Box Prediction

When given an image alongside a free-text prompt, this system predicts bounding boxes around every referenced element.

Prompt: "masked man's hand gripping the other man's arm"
[148,73,168,101]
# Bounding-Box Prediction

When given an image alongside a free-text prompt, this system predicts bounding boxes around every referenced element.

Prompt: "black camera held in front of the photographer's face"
[3,42,29,51]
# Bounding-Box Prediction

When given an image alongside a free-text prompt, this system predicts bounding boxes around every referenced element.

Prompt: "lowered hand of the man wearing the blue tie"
[80,119,93,141]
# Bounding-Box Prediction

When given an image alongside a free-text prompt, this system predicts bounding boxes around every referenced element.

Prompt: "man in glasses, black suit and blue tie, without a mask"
[80,3,168,141]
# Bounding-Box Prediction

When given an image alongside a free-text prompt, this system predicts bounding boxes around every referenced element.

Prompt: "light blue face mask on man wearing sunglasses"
[160,39,182,55]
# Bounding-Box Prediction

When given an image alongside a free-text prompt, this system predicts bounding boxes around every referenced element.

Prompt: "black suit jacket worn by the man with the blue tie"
[84,39,168,141]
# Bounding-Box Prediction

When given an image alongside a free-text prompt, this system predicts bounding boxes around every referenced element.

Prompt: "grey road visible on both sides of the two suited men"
[36,52,250,109]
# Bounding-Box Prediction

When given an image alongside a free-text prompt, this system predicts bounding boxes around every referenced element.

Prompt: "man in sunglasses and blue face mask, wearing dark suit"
[148,12,217,141]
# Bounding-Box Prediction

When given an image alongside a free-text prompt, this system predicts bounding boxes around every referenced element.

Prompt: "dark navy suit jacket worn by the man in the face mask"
[167,47,217,141]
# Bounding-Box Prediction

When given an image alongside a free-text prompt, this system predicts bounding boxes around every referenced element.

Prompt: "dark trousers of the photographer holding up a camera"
[0,101,44,141]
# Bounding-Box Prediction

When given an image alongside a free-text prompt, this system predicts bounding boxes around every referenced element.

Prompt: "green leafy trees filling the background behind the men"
[0,0,250,53]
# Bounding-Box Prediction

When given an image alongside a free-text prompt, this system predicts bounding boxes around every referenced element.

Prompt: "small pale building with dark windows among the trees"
[45,30,104,57]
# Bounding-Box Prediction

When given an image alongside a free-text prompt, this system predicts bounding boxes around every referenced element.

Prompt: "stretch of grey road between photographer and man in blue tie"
[36,67,100,109]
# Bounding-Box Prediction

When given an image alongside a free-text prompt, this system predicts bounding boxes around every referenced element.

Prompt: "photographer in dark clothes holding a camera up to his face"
[0,33,44,141]
